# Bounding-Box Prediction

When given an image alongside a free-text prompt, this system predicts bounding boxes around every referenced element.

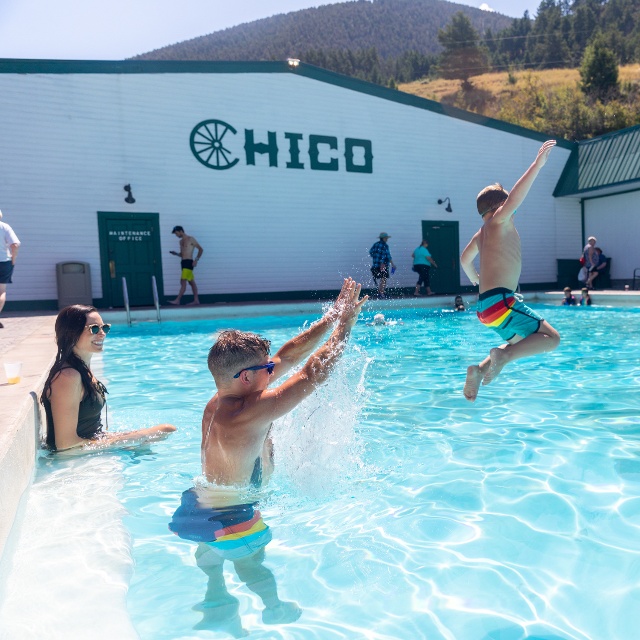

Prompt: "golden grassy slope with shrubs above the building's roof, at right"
[398,64,640,139]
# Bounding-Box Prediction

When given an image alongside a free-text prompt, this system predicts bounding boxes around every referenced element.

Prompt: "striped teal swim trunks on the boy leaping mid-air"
[477,287,543,341]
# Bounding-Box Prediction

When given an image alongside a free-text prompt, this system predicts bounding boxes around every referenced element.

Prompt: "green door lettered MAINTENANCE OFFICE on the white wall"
[98,211,163,307]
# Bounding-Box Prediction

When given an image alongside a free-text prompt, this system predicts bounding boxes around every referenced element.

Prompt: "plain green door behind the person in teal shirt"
[422,220,460,294]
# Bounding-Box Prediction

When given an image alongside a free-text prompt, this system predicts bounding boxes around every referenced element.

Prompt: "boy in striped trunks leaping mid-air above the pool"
[460,140,560,402]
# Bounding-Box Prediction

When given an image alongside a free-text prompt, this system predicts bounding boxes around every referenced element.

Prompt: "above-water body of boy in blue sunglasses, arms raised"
[201,278,367,487]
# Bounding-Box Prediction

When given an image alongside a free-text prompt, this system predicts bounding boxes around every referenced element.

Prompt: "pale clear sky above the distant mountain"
[0,0,540,60]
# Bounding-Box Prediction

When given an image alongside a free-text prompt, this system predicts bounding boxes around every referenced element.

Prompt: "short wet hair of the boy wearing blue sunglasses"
[207,329,271,382]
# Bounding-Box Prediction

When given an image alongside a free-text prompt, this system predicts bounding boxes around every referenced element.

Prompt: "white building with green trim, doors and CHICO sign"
[0,60,640,309]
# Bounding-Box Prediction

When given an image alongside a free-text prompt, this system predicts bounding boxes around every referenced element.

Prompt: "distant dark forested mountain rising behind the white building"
[134,0,512,61]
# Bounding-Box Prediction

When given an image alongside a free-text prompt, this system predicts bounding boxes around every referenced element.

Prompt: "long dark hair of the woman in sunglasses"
[40,304,102,412]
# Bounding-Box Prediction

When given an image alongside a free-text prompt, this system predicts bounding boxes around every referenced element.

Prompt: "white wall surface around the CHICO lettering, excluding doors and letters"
[0,67,581,300]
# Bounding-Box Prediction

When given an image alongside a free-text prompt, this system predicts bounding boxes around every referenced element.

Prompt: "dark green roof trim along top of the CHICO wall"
[0,58,575,149]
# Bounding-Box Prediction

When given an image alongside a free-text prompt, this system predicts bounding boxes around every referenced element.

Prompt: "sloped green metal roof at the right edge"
[553,125,640,197]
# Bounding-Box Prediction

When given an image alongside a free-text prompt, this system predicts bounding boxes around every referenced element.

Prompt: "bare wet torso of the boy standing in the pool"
[202,392,273,486]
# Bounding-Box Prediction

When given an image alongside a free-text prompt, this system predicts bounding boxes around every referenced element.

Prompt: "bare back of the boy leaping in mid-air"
[474,213,522,293]
